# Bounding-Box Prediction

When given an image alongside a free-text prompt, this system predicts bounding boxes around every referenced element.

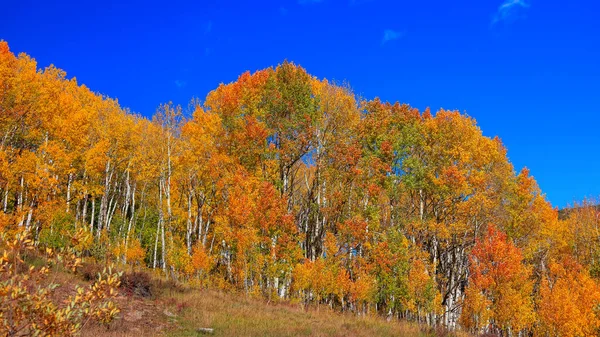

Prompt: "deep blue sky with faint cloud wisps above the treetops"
[0,0,600,207]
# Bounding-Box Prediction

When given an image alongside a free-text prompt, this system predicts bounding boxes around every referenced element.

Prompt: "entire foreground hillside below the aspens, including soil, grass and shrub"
[5,240,460,337]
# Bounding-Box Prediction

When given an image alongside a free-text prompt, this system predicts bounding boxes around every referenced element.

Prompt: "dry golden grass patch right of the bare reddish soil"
[166,291,434,337]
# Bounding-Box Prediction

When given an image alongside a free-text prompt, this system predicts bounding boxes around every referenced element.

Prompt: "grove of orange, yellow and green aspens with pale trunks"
[0,42,600,336]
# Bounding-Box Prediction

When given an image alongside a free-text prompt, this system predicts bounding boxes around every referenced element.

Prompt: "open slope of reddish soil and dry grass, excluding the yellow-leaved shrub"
[71,273,450,337]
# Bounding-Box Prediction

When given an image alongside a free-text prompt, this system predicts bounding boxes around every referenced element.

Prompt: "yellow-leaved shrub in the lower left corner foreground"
[0,231,120,336]
